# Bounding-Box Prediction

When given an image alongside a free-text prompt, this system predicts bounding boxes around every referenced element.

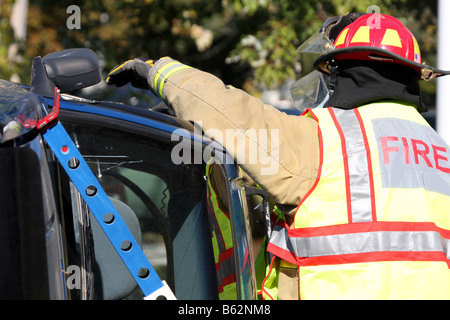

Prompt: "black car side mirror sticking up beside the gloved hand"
[31,48,102,97]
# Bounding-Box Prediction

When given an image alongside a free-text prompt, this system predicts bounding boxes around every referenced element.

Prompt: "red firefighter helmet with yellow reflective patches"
[314,13,449,79]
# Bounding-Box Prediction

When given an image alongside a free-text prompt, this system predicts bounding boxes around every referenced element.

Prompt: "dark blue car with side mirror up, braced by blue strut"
[0,49,267,299]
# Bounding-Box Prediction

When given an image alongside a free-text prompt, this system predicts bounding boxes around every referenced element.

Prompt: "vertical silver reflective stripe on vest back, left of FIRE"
[333,108,372,222]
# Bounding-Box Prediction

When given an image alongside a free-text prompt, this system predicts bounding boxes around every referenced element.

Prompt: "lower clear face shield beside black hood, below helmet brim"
[290,70,329,112]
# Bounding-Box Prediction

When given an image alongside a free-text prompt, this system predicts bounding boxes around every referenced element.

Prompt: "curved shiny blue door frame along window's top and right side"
[60,102,257,300]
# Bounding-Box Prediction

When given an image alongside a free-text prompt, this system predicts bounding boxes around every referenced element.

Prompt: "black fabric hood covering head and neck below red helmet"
[324,60,428,112]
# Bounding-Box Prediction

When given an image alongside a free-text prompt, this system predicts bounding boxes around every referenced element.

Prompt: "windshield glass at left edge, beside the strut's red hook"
[0,80,47,143]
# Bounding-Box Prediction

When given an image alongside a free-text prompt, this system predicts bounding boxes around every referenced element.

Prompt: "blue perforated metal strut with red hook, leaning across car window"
[38,89,176,300]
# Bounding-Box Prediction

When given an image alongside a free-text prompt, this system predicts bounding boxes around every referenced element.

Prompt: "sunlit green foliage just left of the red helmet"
[230,0,322,89]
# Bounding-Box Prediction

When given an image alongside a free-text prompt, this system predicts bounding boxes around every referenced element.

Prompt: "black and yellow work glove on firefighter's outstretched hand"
[106,58,153,90]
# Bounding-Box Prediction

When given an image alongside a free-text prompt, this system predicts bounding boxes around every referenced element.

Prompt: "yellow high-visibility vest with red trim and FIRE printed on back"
[263,102,450,299]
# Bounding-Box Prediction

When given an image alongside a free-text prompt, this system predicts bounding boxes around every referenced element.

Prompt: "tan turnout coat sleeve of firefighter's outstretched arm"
[148,59,319,213]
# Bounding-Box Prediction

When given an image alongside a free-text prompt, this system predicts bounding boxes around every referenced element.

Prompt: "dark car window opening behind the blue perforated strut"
[62,119,218,300]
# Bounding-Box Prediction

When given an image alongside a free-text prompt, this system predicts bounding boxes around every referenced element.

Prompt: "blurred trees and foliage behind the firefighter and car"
[0,0,438,114]
